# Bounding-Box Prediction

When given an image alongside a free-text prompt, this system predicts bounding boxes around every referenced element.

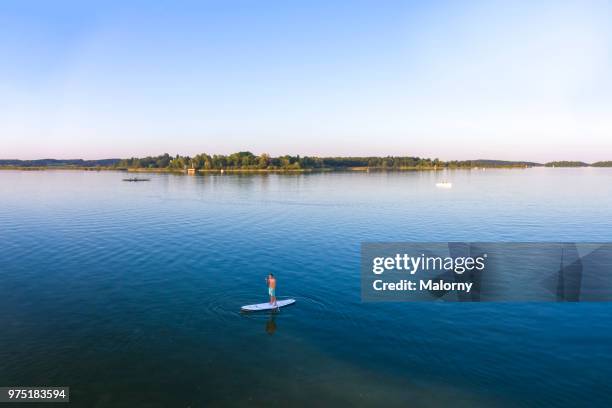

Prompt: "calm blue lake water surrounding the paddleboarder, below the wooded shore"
[0,169,612,407]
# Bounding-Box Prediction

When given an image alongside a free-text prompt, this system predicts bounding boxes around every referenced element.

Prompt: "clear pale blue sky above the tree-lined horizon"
[0,0,612,161]
